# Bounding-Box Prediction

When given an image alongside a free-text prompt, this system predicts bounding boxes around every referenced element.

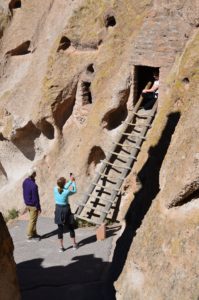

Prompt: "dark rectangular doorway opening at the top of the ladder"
[133,66,159,105]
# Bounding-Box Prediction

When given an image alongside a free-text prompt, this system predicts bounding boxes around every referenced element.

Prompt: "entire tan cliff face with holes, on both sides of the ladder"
[0,0,199,300]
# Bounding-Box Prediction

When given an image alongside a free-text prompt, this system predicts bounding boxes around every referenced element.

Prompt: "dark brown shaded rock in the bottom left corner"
[0,213,21,300]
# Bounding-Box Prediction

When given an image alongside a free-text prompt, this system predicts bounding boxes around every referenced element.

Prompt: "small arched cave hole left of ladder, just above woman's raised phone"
[86,146,106,176]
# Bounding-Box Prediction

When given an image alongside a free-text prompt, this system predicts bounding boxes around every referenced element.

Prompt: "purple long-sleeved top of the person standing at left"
[23,177,41,210]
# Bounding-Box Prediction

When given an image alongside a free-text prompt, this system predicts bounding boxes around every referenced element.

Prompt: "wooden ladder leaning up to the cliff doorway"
[75,84,157,234]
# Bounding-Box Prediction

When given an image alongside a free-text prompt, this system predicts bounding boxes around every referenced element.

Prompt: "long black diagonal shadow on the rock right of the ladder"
[109,112,180,282]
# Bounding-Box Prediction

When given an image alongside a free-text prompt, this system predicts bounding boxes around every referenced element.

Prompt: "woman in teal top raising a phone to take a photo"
[54,176,77,252]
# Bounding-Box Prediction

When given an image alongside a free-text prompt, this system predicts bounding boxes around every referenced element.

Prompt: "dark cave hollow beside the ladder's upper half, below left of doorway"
[102,88,130,130]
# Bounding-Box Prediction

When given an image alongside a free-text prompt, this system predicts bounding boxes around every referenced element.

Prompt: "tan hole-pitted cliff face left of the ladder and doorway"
[0,0,154,213]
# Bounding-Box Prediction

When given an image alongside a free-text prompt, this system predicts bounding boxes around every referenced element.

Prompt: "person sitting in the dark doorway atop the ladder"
[142,72,159,109]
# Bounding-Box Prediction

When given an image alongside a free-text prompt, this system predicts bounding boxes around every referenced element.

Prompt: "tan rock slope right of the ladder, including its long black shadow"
[115,4,199,300]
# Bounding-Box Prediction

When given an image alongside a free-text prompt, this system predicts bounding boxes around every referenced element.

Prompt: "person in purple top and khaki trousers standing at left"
[22,169,41,241]
